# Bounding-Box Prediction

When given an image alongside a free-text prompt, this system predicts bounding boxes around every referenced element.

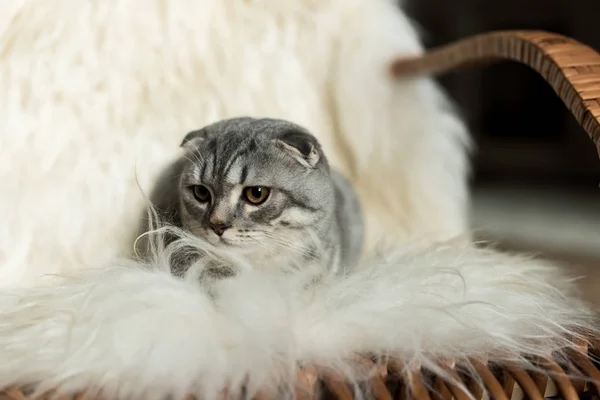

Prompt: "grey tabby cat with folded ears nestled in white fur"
[141,117,363,275]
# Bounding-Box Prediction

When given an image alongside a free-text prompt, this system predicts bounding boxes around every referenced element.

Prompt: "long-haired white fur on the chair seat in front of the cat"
[0,234,597,399]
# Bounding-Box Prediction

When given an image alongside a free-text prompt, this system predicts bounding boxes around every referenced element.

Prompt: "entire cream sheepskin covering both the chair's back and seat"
[0,0,596,399]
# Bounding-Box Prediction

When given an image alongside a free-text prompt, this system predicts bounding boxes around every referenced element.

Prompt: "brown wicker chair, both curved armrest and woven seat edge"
[0,31,600,400]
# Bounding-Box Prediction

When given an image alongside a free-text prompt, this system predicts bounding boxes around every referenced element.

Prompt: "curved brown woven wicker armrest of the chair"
[392,31,600,153]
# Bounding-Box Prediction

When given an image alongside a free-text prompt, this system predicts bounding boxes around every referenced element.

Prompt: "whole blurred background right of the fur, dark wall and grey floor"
[406,0,600,300]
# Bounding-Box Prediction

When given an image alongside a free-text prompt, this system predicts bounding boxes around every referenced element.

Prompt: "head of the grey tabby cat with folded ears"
[180,118,335,253]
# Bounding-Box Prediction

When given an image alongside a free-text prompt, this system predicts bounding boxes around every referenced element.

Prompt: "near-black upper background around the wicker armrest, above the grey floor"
[405,0,600,186]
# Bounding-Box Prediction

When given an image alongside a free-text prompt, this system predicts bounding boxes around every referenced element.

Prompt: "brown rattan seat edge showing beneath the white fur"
[0,342,600,400]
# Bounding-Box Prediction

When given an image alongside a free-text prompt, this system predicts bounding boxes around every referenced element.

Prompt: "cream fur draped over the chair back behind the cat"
[0,0,467,286]
